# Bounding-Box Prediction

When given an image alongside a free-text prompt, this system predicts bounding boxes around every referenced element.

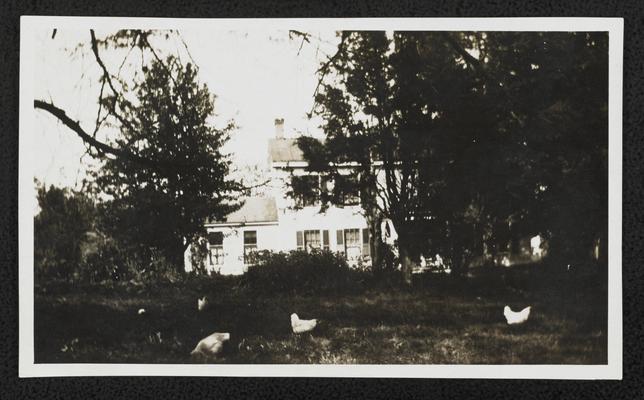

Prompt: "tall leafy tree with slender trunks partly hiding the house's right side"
[299,32,488,282]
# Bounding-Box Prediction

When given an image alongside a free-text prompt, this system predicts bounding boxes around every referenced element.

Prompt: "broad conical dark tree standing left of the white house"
[96,57,240,269]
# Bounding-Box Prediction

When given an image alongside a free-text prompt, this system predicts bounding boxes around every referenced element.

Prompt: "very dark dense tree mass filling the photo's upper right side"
[406,32,608,272]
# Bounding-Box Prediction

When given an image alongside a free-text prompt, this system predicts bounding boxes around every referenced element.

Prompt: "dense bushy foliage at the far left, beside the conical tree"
[34,185,184,284]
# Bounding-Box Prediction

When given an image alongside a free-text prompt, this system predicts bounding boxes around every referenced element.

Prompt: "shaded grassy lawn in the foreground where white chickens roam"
[35,270,607,364]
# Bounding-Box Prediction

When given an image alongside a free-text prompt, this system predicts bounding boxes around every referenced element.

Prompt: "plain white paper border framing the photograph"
[18,16,624,379]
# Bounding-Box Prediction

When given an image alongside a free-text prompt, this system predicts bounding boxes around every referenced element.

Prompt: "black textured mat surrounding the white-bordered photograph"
[0,0,644,400]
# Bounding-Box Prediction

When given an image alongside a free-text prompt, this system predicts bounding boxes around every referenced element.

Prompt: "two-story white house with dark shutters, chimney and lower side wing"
[186,119,370,275]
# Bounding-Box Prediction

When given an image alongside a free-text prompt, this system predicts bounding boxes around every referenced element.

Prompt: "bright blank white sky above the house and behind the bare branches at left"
[33,30,337,188]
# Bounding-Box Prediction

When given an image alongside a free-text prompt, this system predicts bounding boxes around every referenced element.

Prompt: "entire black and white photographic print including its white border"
[19,17,622,379]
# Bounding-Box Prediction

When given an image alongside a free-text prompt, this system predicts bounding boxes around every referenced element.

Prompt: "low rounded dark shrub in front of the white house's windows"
[244,250,366,294]
